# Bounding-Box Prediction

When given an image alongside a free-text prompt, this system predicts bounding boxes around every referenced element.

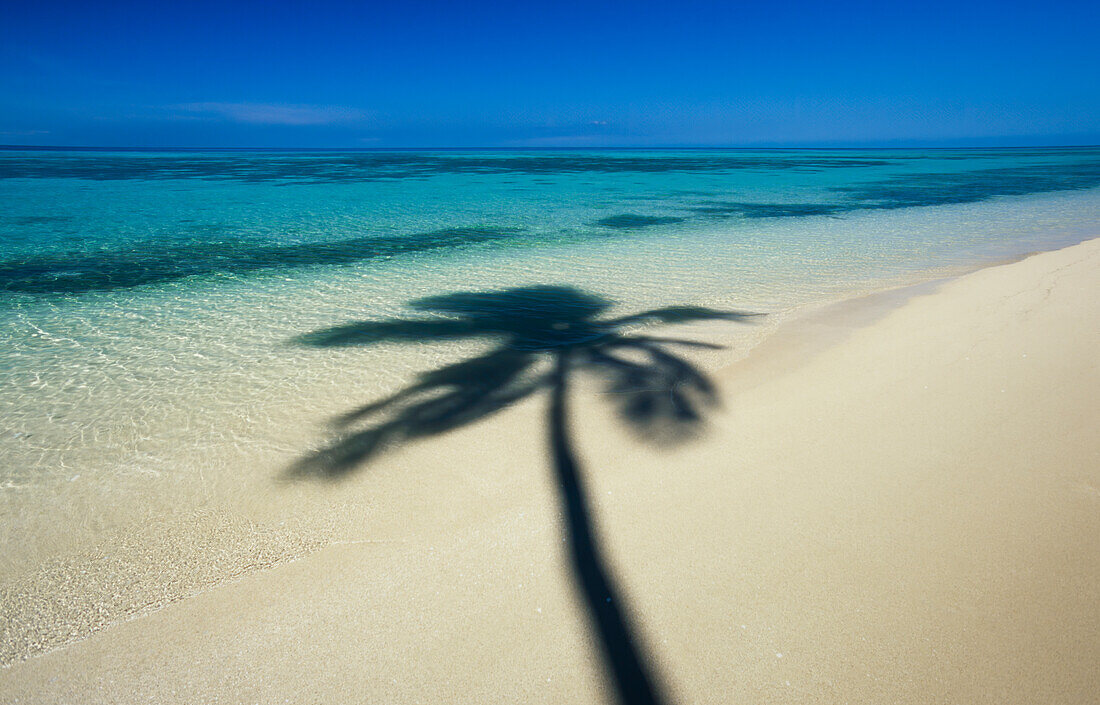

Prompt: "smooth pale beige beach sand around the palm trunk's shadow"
[0,240,1100,705]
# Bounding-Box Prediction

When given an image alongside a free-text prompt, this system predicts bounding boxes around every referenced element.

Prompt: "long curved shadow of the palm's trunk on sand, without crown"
[549,350,664,705]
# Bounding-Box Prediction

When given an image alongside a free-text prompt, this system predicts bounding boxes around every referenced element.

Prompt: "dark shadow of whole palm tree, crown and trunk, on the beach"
[289,286,756,705]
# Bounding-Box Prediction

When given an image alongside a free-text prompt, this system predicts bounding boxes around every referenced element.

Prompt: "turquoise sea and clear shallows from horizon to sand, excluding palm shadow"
[0,148,1100,655]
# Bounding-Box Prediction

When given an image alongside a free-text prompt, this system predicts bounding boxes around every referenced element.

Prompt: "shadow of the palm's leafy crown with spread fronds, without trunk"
[292,286,755,477]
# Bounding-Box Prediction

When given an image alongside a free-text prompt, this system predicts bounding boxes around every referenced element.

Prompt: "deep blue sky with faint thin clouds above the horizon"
[0,0,1100,147]
